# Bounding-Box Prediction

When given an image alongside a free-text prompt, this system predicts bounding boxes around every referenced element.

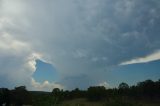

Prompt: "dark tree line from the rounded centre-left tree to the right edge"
[52,80,160,101]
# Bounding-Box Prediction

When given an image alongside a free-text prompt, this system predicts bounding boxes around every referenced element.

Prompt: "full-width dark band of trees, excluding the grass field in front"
[0,80,160,106]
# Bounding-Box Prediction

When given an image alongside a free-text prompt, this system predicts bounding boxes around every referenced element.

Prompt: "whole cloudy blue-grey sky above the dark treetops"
[0,0,160,91]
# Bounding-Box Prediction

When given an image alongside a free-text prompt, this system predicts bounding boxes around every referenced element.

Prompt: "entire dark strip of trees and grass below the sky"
[0,80,160,106]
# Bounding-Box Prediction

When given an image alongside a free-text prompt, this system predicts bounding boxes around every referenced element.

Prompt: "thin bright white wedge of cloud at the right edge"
[120,51,160,65]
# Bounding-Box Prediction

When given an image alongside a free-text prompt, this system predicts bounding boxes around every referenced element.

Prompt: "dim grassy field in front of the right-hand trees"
[57,98,160,106]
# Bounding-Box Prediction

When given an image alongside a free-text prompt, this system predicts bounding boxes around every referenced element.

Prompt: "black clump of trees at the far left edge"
[0,86,32,106]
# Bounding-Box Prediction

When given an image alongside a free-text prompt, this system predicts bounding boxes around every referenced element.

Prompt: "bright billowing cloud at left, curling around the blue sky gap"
[0,33,64,91]
